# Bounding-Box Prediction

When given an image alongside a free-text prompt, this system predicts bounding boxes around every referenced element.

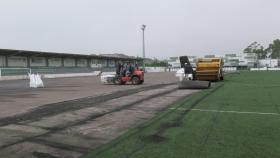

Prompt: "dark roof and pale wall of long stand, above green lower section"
[0,49,142,68]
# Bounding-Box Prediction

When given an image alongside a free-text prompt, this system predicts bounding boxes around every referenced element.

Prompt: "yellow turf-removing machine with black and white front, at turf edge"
[176,56,223,89]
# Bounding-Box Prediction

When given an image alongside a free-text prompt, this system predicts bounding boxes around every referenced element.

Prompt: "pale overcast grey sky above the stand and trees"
[0,0,280,58]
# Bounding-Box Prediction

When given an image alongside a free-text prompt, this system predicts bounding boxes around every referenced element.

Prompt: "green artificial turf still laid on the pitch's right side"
[85,72,280,158]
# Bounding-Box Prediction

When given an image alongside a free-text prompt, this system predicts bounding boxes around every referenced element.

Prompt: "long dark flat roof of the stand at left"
[0,49,142,60]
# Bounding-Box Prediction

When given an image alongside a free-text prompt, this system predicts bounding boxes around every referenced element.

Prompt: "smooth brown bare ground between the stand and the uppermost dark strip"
[0,73,176,118]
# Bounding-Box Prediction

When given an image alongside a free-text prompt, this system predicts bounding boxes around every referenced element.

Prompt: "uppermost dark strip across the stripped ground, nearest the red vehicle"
[0,83,175,127]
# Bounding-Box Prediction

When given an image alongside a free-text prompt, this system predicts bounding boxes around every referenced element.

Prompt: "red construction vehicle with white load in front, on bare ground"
[101,65,144,85]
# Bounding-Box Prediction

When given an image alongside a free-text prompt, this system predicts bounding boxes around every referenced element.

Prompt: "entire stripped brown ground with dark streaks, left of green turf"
[0,73,200,158]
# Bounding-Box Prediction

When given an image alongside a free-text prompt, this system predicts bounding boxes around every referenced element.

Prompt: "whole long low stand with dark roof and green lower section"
[0,49,142,76]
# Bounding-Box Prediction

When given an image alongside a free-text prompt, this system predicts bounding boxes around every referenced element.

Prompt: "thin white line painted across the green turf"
[169,108,280,116]
